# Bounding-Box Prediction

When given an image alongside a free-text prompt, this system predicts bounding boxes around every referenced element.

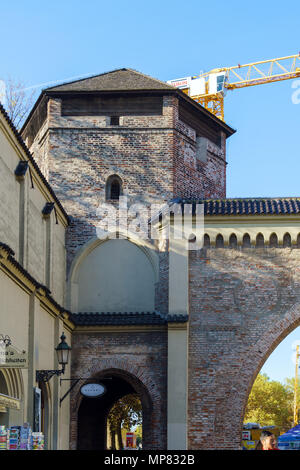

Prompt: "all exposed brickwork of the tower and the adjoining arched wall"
[24,74,300,449]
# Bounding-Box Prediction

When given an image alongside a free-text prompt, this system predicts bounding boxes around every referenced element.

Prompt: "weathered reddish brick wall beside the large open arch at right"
[189,248,300,449]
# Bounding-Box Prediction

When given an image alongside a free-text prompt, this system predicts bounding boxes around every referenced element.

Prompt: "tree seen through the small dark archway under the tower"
[107,394,142,449]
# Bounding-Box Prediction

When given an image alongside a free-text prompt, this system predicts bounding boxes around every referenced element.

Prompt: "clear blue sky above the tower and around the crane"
[0,0,300,382]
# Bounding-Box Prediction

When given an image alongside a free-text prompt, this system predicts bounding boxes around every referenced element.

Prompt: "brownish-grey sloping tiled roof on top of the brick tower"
[46,68,175,92]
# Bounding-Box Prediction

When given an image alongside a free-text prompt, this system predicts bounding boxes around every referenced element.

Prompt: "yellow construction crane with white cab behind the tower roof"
[167,53,300,121]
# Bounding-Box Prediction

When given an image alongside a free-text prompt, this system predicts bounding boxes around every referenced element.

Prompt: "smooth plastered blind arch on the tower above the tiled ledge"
[66,233,159,312]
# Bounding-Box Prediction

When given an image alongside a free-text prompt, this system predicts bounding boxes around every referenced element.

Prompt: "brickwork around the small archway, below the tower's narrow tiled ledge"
[70,329,167,450]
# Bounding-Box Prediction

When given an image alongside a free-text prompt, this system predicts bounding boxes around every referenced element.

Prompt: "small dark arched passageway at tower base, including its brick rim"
[71,360,164,450]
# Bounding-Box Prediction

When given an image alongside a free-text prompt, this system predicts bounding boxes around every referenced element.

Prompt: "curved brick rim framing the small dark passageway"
[70,358,161,449]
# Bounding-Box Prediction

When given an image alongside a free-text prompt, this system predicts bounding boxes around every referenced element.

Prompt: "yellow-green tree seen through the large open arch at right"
[244,374,293,431]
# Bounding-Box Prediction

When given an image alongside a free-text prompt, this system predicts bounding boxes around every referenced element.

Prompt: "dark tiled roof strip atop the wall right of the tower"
[169,197,300,215]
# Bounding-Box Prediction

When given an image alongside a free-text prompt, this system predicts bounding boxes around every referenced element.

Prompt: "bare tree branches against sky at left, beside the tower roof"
[0,78,36,130]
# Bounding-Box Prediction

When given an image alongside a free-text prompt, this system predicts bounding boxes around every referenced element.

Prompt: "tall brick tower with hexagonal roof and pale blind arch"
[22,69,234,448]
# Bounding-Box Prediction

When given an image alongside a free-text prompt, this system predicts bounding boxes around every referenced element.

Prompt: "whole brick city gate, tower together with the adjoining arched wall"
[23,69,300,449]
